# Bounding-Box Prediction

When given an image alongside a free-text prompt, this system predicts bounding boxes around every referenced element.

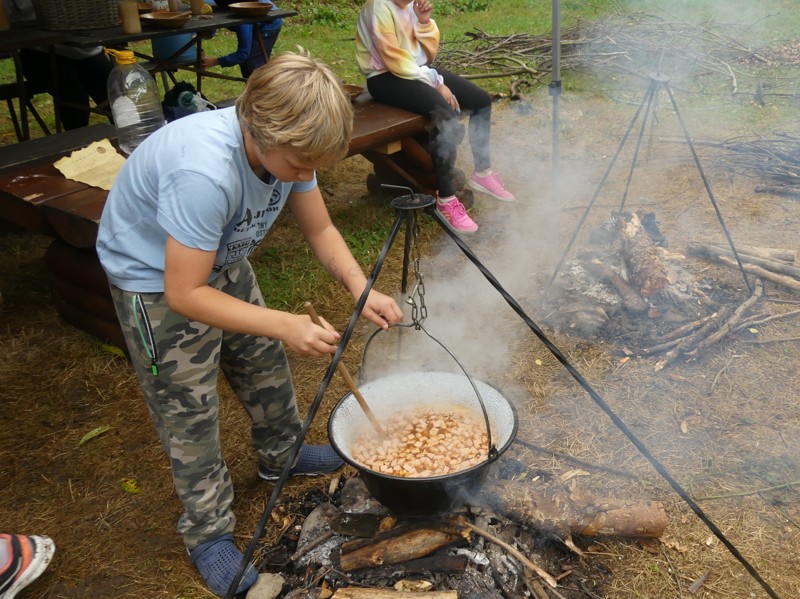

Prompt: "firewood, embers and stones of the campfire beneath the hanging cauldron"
[248,470,667,599]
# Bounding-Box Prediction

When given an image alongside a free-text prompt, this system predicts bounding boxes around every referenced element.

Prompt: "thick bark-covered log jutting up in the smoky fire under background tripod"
[619,214,669,298]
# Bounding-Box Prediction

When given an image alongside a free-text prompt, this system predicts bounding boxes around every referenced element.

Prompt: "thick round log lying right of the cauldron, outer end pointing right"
[480,480,667,538]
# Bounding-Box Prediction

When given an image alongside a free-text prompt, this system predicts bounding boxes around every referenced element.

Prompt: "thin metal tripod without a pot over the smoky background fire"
[545,73,753,293]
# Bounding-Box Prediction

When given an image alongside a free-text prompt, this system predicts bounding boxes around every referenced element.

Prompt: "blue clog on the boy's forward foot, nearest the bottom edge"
[189,534,258,597]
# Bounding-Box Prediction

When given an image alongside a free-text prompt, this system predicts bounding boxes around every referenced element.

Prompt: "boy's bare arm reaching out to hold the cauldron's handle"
[288,187,403,329]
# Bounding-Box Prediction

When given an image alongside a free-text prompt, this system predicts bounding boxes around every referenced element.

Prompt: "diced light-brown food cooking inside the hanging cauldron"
[351,408,489,478]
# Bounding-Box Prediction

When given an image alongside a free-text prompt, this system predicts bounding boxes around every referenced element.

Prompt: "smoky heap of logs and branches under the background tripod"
[545,211,800,370]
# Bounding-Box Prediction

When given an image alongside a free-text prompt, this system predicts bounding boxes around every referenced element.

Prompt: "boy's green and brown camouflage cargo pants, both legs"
[111,261,301,551]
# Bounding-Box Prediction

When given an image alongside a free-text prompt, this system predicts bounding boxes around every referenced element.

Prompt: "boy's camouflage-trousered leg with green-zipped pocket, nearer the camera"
[111,284,235,550]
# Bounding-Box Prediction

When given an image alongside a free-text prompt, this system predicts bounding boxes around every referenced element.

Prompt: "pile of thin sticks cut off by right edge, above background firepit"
[684,133,800,198]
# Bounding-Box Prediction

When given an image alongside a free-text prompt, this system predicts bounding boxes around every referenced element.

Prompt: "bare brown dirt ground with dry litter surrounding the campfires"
[0,76,800,599]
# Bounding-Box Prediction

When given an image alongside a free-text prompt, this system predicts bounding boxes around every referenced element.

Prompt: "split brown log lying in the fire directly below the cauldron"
[339,523,469,572]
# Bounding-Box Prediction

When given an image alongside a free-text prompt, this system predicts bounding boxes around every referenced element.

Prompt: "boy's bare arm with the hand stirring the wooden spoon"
[164,237,340,357]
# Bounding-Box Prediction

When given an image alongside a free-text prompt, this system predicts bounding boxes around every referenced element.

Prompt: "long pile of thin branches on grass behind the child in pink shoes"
[437,13,780,96]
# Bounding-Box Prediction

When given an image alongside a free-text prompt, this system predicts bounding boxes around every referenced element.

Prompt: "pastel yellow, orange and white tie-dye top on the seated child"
[356,0,442,87]
